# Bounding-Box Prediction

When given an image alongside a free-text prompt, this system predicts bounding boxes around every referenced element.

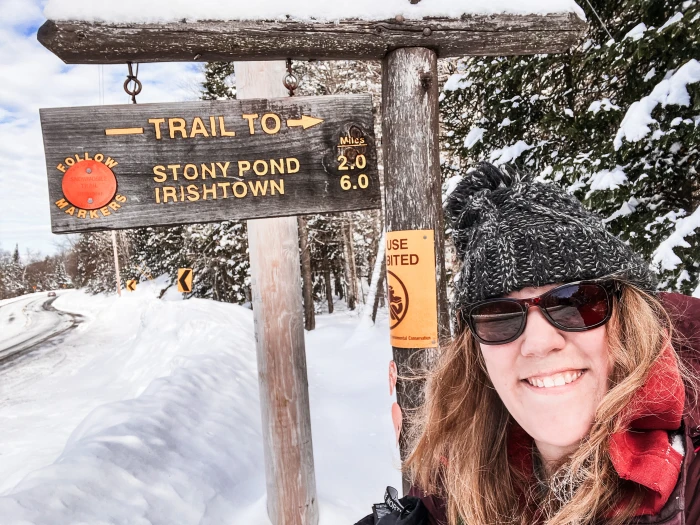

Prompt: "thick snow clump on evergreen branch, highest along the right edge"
[614,59,700,150]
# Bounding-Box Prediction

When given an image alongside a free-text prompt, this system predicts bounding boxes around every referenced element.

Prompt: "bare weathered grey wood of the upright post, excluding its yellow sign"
[382,48,450,491]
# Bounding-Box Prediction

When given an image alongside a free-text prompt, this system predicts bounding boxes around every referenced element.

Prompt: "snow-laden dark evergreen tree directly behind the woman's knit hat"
[441,0,700,293]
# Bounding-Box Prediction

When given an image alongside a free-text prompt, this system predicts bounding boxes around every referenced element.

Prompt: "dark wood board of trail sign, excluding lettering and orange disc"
[40,94,381,233]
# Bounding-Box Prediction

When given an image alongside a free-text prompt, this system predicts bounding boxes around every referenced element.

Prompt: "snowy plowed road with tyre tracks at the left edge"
[0,293,80,364]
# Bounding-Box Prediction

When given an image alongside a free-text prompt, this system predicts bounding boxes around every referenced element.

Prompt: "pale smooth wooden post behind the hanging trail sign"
[239,62,319,525]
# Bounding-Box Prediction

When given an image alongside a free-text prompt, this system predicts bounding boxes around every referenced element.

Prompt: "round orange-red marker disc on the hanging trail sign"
[61,160,117,210]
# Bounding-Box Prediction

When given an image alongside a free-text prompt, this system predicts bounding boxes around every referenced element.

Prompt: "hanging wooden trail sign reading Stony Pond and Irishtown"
[41,95,381,233]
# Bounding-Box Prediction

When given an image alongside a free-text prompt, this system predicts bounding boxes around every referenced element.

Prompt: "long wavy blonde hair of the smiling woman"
[404,285,689,525]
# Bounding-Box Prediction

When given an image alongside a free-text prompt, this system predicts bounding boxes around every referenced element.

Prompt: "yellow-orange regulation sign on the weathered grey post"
[386,230,438,348]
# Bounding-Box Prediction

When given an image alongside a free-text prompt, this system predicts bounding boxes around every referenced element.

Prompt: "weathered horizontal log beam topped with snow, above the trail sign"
[37,13,586,64]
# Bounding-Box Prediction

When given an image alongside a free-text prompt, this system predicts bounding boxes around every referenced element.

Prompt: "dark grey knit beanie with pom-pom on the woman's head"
[445,163,656,309]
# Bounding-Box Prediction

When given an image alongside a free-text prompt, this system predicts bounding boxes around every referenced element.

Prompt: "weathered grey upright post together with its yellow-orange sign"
[382,47,450,493]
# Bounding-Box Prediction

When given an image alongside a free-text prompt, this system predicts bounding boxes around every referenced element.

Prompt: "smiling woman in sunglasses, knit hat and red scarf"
[360,164,700,525]
